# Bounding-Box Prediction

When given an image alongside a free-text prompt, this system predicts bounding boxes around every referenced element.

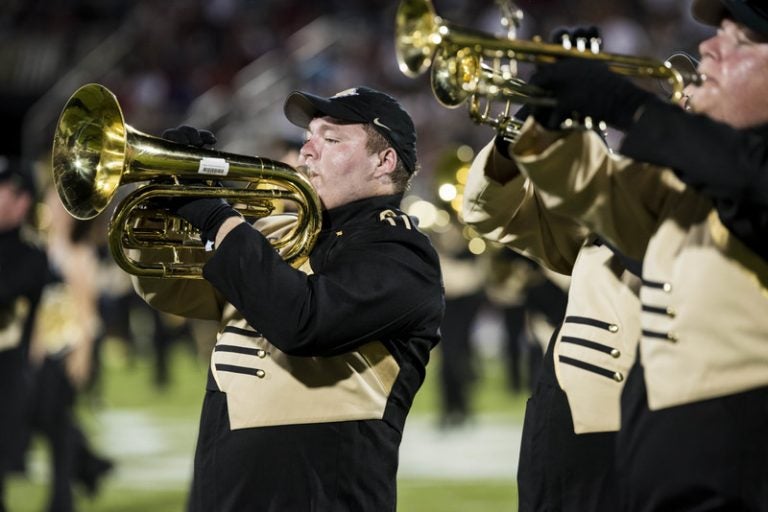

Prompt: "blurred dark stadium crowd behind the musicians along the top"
[0,0,706,171]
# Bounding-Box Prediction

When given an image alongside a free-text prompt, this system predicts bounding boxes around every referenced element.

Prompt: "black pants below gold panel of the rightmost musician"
[617,363,768,512]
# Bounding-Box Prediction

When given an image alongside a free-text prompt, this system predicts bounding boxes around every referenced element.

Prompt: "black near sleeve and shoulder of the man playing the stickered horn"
[204,224,442,356]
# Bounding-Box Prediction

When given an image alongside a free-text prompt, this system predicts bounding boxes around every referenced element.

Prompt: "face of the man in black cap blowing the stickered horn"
[299,117,392,209]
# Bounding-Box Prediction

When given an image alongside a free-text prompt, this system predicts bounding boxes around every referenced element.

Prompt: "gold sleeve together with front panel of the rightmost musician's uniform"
[513,119,768,410]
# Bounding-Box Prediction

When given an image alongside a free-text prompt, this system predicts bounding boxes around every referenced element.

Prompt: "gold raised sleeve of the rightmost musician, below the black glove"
[512,119,685,260]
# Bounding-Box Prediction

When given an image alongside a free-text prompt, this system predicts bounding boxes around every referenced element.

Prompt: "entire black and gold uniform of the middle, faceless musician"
[463,140,639,512]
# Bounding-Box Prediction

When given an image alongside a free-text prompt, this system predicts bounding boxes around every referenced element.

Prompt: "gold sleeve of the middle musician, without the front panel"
[462,138,588,275]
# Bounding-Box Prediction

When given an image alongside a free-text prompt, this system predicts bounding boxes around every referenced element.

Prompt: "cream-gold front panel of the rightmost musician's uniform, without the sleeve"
[640,204,768,410]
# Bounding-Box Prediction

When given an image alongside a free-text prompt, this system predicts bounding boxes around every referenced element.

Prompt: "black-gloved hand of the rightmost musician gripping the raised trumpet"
[530,58,661,131]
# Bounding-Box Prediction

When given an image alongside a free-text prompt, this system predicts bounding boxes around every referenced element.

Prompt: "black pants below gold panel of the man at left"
[187,390,400,512]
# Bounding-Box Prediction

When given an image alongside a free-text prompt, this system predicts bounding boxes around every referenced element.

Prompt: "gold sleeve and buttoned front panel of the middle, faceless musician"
[462,142,640,434]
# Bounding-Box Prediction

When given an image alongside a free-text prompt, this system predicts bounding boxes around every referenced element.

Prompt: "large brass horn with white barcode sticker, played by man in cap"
[52,84,321,279]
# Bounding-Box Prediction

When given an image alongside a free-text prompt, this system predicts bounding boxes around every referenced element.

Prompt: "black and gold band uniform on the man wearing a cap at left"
[136,194,443,512]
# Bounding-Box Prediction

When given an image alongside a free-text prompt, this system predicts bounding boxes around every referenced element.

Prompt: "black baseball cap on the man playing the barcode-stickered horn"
[283,87,416,173]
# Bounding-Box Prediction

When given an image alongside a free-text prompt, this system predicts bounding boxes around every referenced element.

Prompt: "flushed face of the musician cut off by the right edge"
[687,19,768,128]
